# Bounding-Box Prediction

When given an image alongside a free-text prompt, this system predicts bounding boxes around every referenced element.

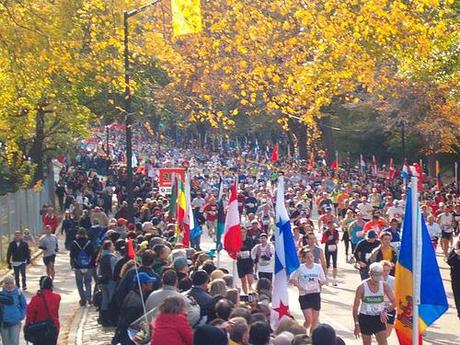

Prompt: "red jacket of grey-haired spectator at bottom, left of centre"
[150,313,193,345]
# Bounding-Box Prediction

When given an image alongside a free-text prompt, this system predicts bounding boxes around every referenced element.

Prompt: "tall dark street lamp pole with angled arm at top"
[123,0,159,222]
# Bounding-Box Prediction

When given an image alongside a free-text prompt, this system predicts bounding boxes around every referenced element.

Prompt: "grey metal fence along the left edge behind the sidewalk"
[0,170,54,261]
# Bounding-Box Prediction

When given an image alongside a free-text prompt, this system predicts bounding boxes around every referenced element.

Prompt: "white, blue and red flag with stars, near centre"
[271,176,300,327]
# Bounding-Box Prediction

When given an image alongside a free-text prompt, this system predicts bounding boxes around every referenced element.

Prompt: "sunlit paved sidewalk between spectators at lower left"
[12,240,80,345]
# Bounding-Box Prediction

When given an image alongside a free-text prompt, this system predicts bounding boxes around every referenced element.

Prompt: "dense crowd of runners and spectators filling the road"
[0,137,460,345]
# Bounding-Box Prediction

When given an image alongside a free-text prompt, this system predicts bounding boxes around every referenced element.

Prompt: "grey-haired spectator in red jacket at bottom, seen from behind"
[151,296,193,345]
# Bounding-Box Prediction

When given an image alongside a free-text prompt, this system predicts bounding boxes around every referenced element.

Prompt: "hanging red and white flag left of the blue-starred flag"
[223,180,243,260]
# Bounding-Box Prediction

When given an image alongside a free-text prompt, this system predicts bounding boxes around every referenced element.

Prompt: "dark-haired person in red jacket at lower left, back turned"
[24,276,61,345]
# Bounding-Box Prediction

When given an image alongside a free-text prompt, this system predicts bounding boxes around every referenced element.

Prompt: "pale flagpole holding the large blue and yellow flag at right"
[411,176,422,345]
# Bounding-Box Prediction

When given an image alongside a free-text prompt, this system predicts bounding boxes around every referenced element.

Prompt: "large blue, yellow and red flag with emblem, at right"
[395,187,448,345]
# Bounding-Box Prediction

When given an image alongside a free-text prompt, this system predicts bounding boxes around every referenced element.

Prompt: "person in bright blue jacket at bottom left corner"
[0,275,27,345]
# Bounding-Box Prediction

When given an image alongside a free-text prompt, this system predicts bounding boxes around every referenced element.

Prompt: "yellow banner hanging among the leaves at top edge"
[171,0,203,36]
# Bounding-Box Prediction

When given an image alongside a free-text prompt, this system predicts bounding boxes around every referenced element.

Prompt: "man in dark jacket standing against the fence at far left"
[6,231,30,290]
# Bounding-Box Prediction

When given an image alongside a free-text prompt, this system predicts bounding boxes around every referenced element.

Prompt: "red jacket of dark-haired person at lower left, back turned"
[26,289,61,333]
